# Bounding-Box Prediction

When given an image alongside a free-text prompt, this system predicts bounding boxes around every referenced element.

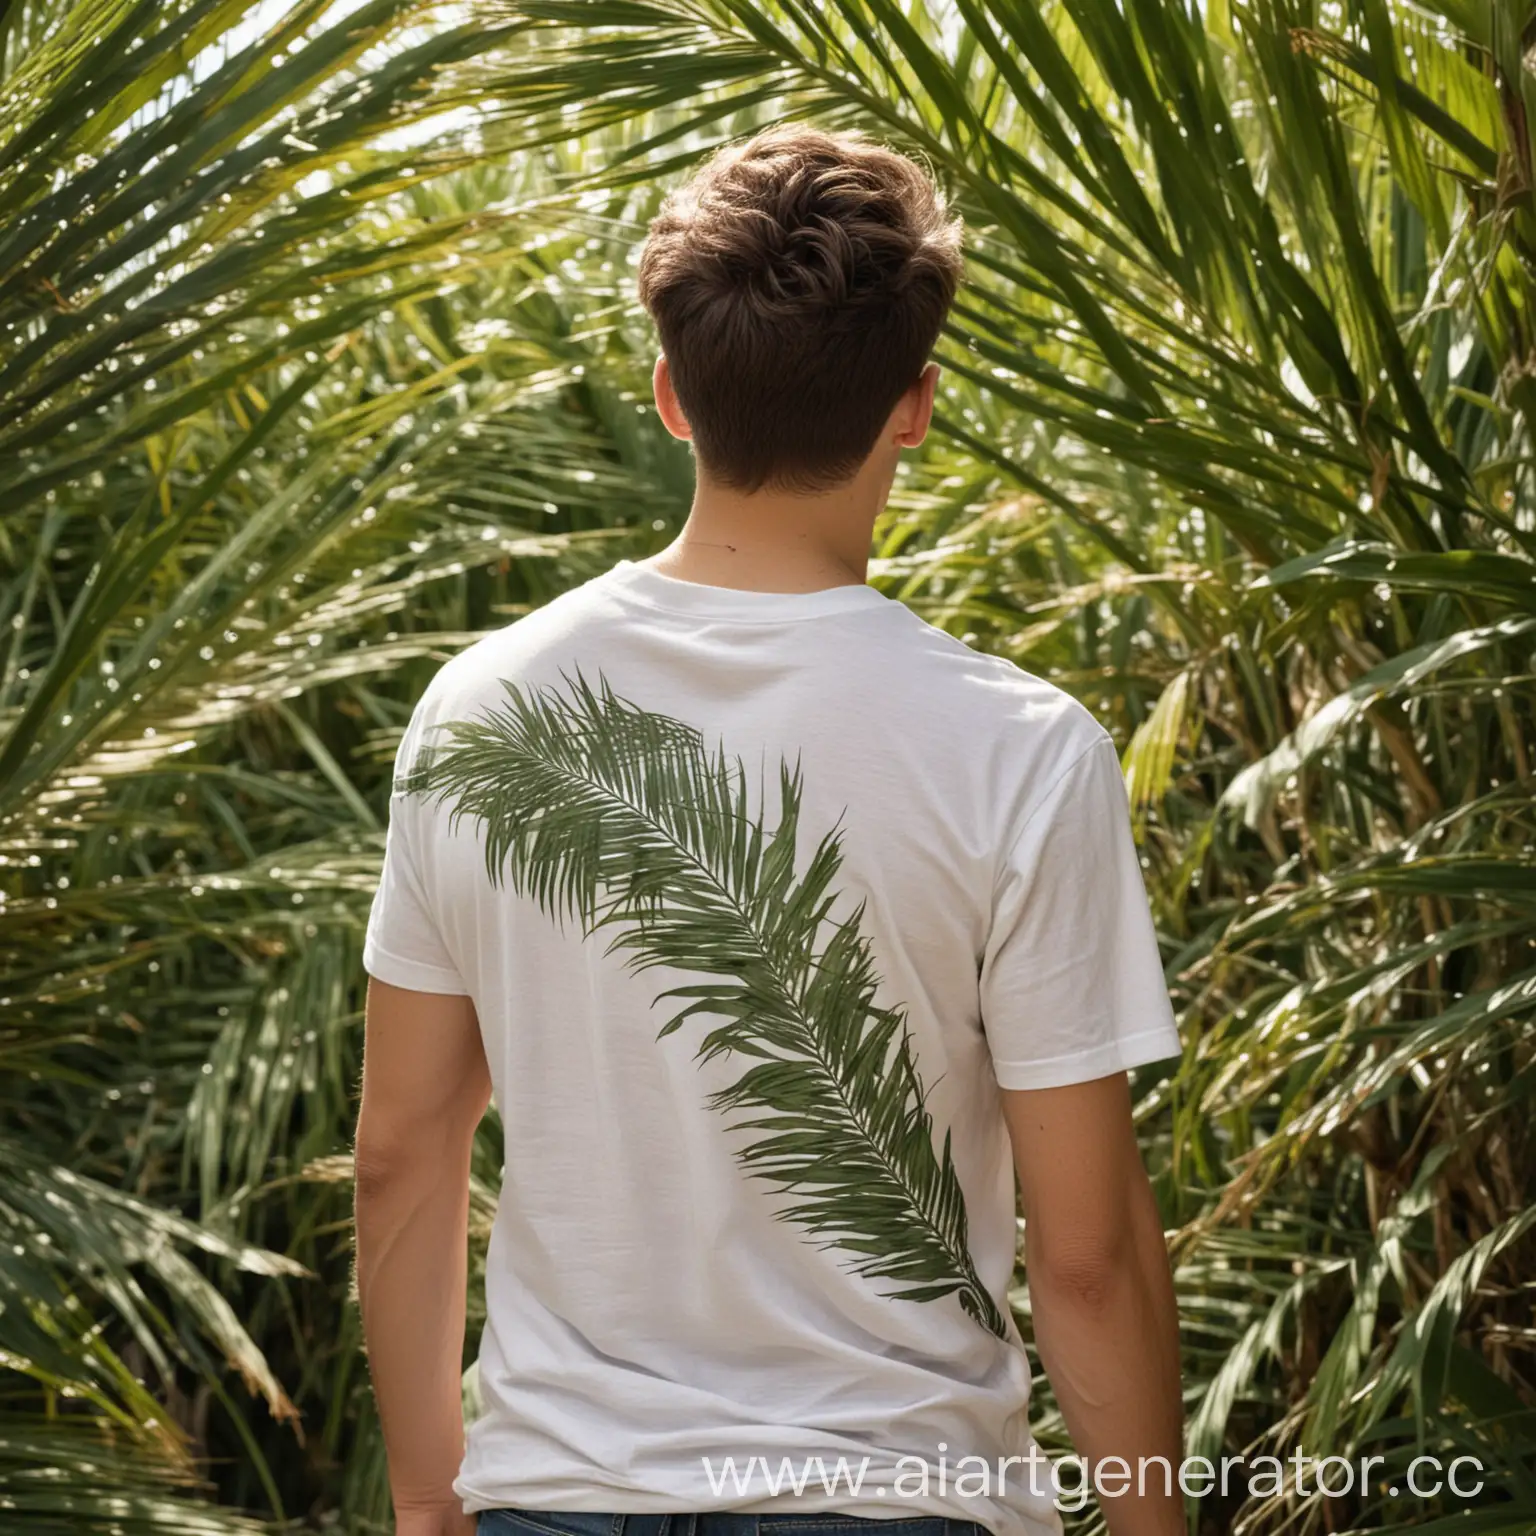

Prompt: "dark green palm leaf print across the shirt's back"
[398,676,1008,1338]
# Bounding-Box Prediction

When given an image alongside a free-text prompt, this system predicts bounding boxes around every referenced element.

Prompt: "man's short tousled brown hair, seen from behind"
[639,126,962,492]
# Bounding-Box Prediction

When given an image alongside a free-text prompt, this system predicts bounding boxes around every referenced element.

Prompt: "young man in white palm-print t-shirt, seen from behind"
[356,129,1183,1536]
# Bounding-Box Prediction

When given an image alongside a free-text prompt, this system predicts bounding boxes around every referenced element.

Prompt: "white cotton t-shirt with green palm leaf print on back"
[366,561,1180,1536]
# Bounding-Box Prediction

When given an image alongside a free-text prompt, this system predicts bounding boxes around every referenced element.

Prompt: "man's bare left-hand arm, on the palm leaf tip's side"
[356,980,490,1536]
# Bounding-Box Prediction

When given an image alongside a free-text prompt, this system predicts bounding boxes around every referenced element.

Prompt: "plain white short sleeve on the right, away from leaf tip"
[980,736,1181,1087]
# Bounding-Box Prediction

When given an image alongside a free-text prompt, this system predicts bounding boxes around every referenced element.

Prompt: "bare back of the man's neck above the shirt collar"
[644,460,889,591]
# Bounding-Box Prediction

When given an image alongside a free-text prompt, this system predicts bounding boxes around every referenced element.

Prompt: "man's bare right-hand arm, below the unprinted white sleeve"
[1003,1074,1184,1536]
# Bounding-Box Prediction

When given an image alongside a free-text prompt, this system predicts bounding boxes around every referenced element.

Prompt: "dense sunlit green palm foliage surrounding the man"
[0,0,1536,1536]
